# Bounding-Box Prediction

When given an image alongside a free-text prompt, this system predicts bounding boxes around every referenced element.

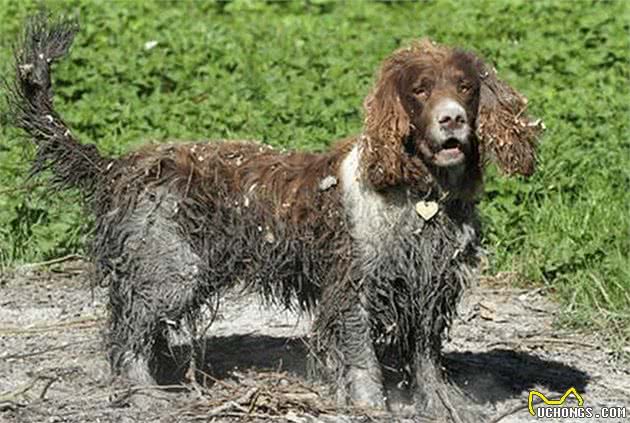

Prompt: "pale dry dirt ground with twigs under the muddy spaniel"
[0,261,630,423]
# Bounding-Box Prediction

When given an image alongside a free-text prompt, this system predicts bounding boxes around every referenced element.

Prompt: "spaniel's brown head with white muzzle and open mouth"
[363,40,534,195]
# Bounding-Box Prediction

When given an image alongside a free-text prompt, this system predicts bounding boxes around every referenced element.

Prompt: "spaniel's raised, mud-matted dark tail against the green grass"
[4,12,107,198]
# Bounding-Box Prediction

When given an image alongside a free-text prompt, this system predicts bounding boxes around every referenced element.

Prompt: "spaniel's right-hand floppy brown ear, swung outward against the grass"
[477,60,544,176]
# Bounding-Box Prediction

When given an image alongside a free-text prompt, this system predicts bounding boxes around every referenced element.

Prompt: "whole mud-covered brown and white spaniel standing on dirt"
[7,15,539,416]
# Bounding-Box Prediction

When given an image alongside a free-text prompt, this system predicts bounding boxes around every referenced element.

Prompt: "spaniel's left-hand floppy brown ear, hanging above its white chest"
[361,53,410,190]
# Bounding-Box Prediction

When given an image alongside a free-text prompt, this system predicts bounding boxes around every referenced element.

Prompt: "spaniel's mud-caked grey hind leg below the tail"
[97,189,209,385]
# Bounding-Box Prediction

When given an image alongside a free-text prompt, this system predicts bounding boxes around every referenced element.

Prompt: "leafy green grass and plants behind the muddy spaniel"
[0,0,630,342]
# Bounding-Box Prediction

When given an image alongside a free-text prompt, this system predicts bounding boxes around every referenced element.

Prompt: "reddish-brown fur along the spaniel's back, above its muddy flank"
[118,138,356,225]
